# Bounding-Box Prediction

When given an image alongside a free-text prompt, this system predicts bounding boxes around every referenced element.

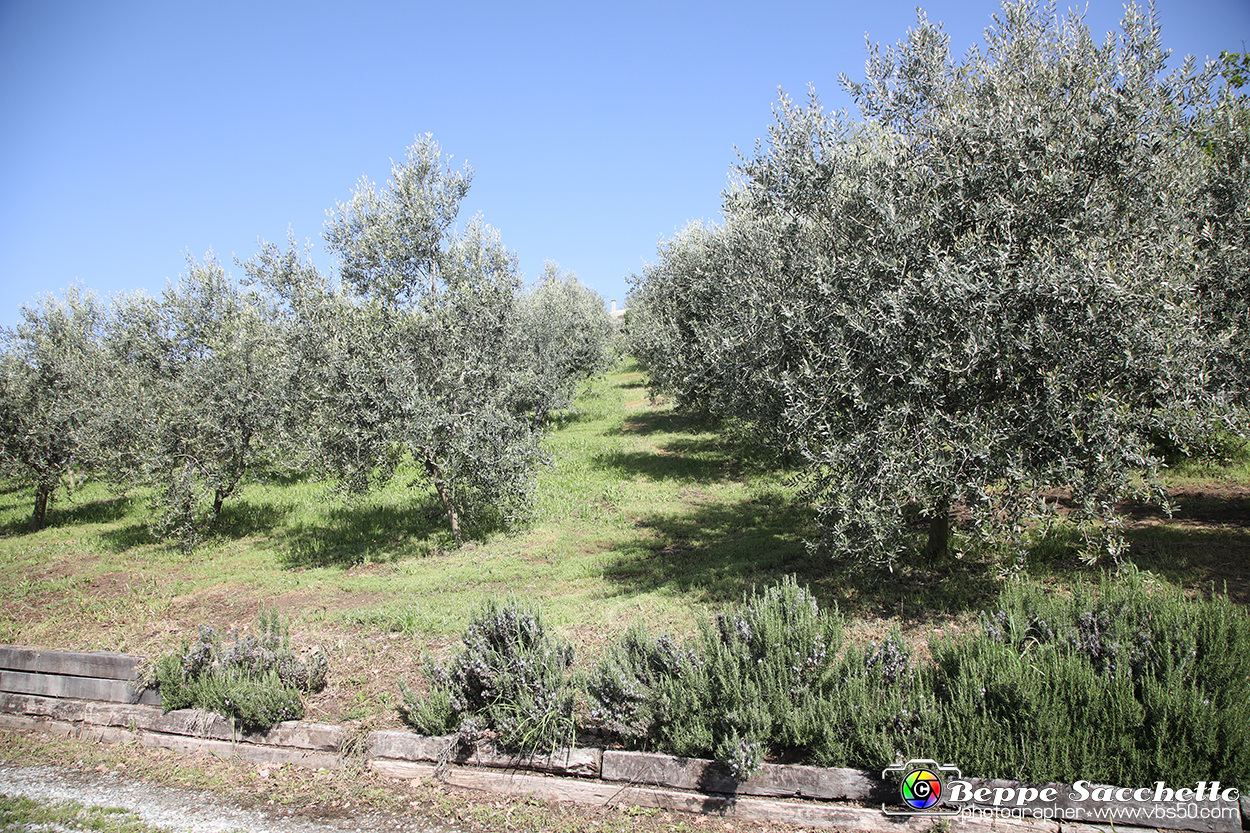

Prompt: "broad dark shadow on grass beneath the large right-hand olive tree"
[604,494,1000,622]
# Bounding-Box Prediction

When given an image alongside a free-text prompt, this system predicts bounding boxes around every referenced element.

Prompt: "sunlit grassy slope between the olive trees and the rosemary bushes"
[0,357,1250,725]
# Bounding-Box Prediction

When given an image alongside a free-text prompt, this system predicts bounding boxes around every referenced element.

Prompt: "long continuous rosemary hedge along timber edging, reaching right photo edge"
[585,569,1250,785]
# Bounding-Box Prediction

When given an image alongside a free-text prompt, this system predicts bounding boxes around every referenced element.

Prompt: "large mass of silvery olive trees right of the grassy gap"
[629,0,1250,564]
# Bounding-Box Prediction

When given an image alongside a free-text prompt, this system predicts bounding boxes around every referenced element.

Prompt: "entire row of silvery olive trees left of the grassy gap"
[0,136,613,547]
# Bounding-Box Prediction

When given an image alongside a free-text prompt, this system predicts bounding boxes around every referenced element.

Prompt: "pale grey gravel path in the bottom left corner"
[0,764,450,833]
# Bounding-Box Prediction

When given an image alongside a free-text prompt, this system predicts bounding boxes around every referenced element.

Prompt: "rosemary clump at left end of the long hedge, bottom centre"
[586,577,843,780]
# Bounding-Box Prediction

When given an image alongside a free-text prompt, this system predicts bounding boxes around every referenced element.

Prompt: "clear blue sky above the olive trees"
[0,0,1250,325]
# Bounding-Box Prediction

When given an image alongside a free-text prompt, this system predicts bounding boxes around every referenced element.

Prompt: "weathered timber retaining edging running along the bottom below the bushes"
[0,645,1250,833]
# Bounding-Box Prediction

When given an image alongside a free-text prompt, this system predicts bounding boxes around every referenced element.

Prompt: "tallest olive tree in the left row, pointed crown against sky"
[248,136,541,542]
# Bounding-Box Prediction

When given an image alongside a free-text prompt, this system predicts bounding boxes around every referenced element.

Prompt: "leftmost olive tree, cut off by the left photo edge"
[0,288,103,530]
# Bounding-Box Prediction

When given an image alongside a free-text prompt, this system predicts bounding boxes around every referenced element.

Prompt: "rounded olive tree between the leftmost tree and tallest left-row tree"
[96,253,289,549]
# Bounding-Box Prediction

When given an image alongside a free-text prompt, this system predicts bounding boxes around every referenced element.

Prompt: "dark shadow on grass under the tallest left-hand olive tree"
[279,503,446,569]
